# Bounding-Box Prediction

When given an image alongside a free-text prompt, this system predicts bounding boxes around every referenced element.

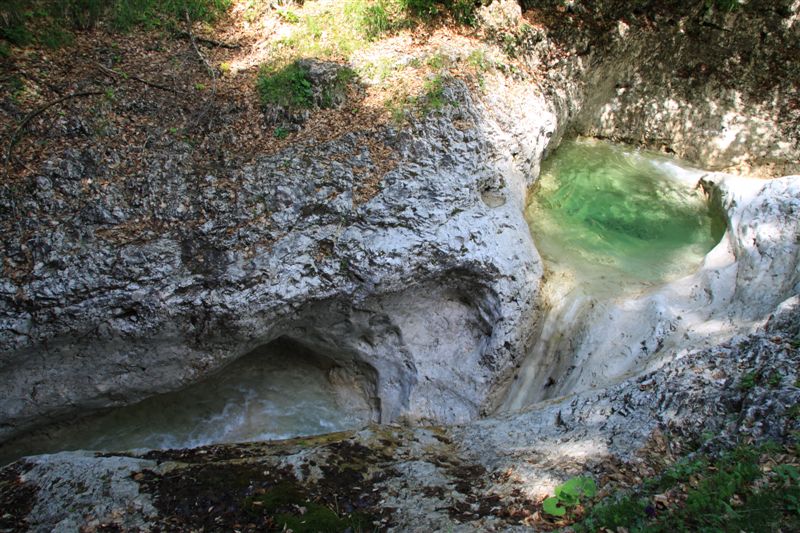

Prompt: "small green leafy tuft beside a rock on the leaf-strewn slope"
[256,61,314,108]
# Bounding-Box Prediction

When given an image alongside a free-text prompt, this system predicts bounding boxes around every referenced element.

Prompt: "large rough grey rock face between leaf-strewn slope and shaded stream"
[0,81,557,438]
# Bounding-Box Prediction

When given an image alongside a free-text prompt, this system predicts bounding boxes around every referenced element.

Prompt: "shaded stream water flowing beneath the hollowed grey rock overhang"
[0,337,376,464]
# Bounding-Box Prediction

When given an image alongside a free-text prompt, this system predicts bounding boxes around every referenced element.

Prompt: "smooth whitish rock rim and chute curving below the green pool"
[502,173,800,410]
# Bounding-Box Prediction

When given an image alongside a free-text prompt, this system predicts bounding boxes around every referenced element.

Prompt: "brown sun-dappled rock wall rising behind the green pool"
[574,0,800,176]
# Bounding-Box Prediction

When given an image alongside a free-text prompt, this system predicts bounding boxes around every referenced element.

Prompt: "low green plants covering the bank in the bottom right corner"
[574,443,800,532]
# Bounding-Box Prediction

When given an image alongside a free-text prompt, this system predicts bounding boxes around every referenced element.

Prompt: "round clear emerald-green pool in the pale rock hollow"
[526,140,725,290]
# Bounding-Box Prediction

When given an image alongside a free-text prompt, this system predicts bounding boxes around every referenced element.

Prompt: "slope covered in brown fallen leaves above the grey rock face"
[0,2,524,189]
